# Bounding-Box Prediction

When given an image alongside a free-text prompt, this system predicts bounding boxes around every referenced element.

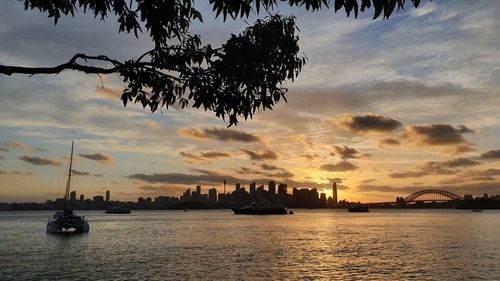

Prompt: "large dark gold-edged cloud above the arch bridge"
[404,124,475,154]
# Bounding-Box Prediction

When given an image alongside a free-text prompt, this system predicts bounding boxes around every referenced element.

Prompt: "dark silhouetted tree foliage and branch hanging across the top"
[0,0,420,126]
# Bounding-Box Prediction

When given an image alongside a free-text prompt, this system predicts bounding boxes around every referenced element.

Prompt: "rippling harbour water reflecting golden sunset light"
[0,210,500,280]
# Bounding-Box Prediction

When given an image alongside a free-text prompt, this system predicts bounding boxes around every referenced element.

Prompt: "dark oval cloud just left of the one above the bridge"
[335,114,401,133]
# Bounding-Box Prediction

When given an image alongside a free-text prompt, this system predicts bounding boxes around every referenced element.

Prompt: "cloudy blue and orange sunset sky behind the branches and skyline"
[0,0,500,202]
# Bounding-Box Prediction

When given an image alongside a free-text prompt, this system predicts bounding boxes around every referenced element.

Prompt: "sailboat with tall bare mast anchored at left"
[47,141,90,233]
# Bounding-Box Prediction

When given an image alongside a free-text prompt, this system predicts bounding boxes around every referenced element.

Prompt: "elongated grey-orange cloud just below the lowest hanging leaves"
[177,127,261,142]
